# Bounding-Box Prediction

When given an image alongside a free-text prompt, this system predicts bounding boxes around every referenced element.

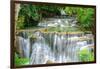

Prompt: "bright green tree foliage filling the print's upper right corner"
[65,7,95,32]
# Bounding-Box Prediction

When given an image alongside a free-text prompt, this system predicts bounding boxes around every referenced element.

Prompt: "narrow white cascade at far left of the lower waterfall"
[16,36,30,58]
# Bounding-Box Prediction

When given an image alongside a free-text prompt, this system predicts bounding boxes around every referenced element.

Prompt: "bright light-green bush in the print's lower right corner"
[79,48,94,62]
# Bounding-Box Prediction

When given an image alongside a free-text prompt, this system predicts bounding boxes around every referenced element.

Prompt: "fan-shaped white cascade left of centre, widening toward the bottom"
[30,32,51,64]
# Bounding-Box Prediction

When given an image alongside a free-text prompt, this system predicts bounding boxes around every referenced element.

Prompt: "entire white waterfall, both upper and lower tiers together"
[15,16,94,64]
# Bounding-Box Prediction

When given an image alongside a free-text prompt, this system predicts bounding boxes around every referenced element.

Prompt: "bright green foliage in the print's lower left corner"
[15,54,29,66]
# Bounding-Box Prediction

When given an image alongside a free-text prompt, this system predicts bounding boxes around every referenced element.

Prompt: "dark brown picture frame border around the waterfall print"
[10,1,96,69]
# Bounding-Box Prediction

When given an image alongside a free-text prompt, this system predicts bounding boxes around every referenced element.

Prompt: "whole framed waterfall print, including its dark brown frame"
[11,1,96,68]
